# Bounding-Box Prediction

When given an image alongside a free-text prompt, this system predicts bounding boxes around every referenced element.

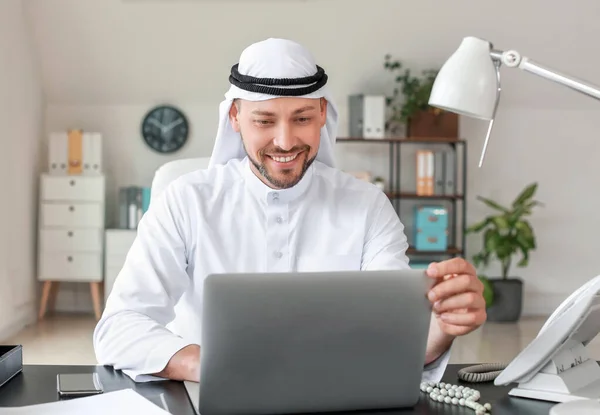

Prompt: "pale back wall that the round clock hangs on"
[24,0,600,313]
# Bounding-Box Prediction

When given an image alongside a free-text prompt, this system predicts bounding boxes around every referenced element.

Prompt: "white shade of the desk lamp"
[429,37,499,120]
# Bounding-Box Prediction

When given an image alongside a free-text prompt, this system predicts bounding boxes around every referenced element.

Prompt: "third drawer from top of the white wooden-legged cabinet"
[40,228,102,252]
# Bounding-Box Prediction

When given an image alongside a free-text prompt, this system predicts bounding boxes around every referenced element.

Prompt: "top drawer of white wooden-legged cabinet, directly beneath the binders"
[42,175,105,202]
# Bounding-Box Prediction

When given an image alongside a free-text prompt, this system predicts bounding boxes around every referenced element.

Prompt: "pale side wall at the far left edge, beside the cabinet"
[0,0,43,341]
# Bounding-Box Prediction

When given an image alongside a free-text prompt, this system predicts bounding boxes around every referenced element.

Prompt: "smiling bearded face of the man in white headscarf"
[229,97,327,189]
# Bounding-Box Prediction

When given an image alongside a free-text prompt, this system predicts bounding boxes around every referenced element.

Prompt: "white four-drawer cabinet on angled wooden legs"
[38,174,105,318]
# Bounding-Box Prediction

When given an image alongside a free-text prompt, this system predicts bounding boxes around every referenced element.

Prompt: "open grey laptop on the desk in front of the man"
[186,270,433,415]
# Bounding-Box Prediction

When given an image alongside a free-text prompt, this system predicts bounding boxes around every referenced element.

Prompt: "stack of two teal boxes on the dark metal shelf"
[415,205,448,251]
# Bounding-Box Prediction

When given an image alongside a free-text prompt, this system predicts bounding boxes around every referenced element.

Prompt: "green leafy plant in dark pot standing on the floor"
[466,183,541,322]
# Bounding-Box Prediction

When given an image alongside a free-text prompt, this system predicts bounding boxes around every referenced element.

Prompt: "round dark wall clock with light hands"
[142,105,189,153]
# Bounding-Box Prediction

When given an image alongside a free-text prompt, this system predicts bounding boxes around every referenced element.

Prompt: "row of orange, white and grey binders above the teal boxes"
[416,150,456,196]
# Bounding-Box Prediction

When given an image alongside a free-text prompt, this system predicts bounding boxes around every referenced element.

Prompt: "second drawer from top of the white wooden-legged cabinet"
[42,203,104,228]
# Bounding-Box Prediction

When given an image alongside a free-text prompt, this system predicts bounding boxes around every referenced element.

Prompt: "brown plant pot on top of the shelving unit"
[406,110,458,140]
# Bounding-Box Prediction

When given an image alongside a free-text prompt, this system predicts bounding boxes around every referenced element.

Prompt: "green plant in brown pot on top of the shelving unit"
[384,54,458,138]
